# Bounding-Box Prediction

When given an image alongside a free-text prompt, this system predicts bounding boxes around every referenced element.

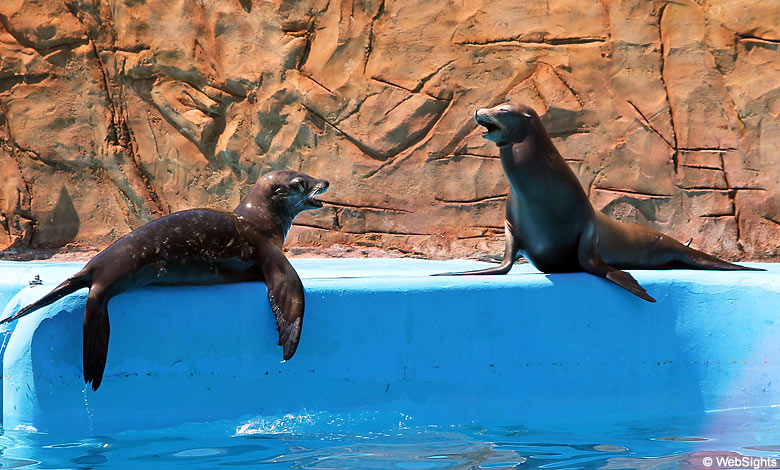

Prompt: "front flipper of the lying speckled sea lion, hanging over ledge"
[260,247,304,361]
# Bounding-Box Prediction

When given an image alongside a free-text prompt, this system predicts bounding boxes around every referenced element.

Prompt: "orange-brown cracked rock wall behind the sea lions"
[0,0,780,259]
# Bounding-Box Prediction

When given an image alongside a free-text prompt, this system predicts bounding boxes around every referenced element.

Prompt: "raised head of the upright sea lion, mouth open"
[474,103,539,147]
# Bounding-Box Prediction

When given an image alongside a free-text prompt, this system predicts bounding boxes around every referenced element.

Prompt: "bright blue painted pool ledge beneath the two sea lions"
[0,259,780,434]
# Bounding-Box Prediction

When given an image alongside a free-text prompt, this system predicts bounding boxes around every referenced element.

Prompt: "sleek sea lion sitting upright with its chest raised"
[437,103,761,302]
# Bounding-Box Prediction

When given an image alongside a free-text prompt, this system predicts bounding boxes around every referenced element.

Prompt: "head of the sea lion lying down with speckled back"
[244,170,329,218]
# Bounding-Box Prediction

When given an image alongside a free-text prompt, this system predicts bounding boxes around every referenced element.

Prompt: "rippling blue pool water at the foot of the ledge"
[0,407,780,469]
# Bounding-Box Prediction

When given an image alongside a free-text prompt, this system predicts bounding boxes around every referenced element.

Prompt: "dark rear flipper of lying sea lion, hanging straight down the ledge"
[82,289,111,390]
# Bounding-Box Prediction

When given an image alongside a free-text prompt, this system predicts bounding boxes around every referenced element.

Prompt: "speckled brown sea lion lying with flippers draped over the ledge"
[0,170,328,390]
